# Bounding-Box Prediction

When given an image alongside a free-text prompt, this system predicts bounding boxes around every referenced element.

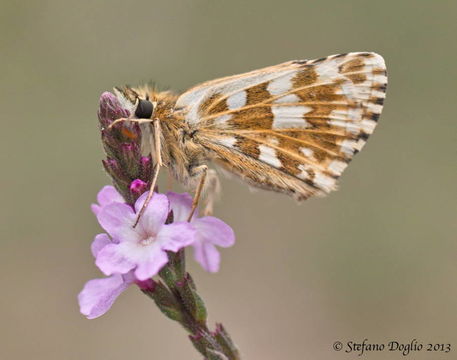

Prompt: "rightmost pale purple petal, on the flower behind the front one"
[192,216,235,247]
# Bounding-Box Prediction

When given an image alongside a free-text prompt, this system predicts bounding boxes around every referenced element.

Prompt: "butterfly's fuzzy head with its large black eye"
[114,86,157,119]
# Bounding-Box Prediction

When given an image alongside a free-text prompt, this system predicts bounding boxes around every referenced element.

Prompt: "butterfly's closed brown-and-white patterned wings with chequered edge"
[177,53,387,199]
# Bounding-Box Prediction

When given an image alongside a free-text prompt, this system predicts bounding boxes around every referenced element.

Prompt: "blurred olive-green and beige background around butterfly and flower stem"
[0,0,457,360]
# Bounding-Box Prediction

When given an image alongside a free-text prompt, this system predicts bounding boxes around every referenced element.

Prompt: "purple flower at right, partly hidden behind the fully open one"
[167,192,235,272]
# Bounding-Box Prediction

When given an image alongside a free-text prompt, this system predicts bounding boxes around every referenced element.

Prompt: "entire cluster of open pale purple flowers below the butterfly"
[78,186,235,319]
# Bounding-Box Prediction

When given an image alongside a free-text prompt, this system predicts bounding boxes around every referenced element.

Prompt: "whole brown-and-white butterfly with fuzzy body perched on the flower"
[110,52,387,224]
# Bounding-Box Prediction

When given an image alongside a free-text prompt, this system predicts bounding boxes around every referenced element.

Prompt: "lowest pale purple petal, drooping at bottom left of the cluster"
[78,275,131,319]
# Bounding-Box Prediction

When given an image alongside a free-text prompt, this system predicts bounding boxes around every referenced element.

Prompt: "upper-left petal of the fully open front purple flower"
[97,203,137,241]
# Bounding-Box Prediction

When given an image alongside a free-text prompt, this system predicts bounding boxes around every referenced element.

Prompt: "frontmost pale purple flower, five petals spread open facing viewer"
[95,192,195,280]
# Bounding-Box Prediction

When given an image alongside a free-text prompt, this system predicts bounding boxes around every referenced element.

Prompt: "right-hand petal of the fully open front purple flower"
[156,222,195,252]
